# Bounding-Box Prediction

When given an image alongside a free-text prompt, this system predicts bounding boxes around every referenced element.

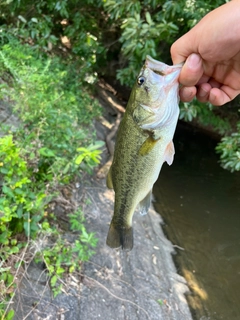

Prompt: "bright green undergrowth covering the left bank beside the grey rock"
[0,38,103,319]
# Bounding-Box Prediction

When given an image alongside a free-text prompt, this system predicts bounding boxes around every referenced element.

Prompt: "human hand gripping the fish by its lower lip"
[171,0,240,105]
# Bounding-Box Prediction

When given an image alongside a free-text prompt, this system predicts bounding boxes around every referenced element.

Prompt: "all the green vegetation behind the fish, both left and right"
[0,0,240,319]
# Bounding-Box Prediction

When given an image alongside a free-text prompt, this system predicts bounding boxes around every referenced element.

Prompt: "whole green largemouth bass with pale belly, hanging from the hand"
[107,56,182,250]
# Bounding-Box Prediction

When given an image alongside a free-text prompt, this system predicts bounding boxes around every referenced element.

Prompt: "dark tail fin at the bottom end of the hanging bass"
[107,223,133,250]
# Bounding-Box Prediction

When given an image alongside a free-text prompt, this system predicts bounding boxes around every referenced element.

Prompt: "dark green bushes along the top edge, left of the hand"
[0,0,225,86]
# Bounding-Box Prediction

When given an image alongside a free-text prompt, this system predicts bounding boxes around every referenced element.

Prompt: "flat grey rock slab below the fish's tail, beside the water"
[77,181,192,320]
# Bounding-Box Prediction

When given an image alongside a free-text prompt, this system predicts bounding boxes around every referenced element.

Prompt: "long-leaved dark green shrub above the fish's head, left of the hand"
[104,0,225,86]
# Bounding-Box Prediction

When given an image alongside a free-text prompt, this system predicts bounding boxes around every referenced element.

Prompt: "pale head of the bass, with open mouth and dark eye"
[130,56,182,130]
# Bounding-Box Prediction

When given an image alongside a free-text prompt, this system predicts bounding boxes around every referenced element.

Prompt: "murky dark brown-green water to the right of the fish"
[154,122,240,320]
